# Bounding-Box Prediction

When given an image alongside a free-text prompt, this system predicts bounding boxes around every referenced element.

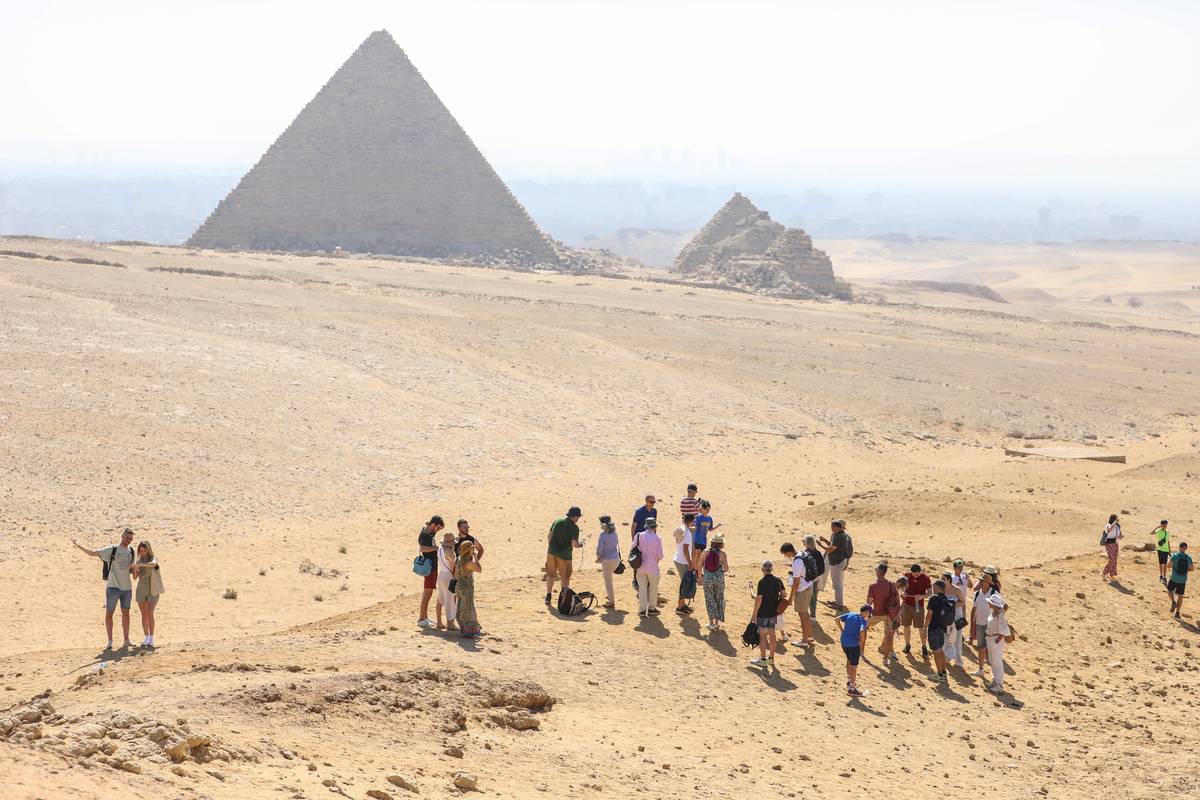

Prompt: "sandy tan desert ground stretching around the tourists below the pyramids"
[0,237,1200,799]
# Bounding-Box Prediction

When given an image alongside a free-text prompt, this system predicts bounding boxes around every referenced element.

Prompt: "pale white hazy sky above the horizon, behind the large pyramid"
[0,0,1200,192]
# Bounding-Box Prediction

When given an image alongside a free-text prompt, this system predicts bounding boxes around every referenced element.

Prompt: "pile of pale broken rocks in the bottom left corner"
[0,693,259,774]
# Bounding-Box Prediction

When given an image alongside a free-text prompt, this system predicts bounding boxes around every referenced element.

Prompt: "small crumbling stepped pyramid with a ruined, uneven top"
[673,193,851,299]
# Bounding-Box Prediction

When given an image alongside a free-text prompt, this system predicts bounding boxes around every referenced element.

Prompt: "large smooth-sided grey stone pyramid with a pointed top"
[187,30,557,263]
